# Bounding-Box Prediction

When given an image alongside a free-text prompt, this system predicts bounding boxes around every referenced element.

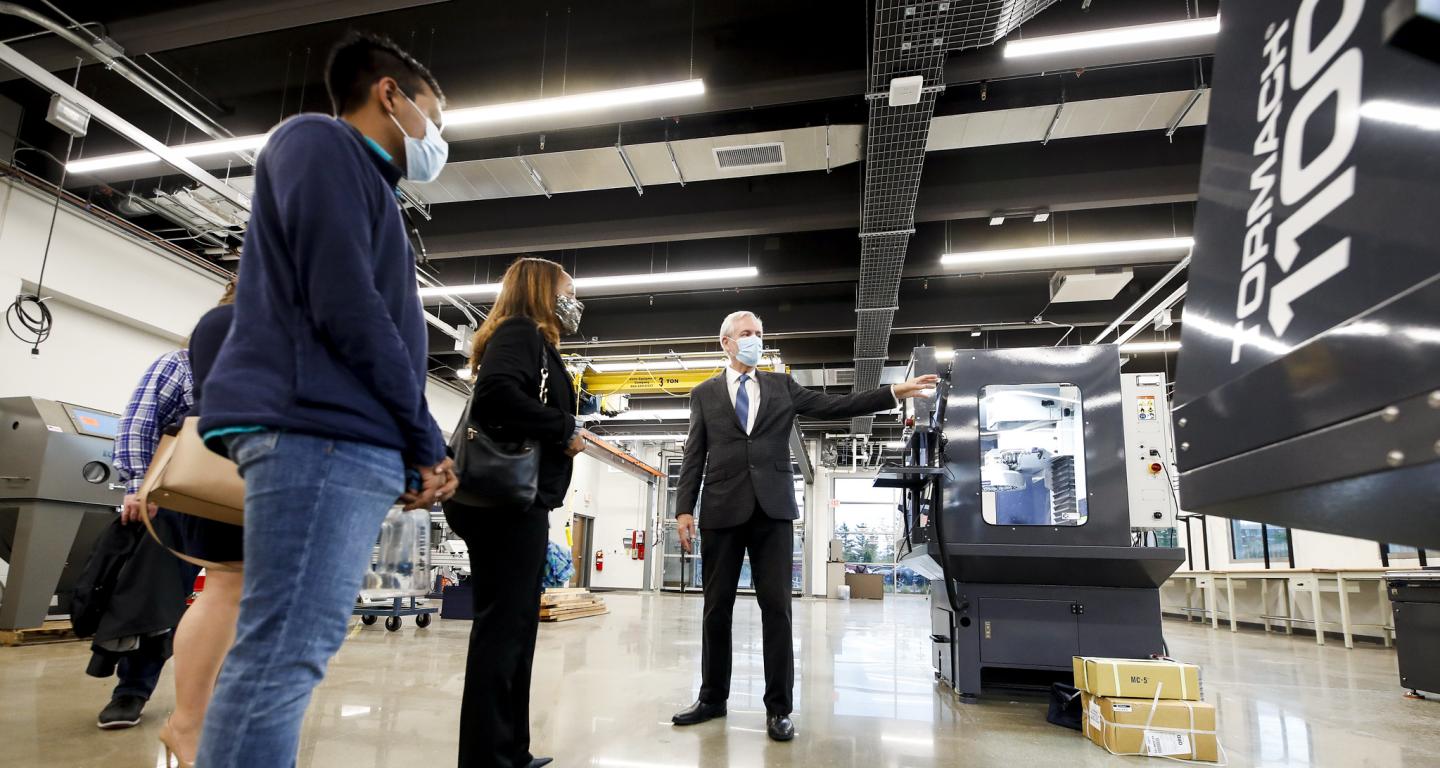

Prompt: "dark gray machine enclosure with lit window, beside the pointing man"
[877,346,1184,696]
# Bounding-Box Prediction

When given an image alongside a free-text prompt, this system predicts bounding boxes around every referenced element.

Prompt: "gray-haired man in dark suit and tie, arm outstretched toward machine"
[672,311,937,741]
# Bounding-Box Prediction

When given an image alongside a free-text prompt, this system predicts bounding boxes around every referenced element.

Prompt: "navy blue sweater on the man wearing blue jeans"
[200,115,445,464]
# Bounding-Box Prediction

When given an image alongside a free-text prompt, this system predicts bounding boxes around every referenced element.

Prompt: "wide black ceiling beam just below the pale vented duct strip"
[423,128,1202,259]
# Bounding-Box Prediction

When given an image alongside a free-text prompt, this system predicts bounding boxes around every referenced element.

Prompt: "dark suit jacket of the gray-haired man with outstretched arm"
[675,370,896,529]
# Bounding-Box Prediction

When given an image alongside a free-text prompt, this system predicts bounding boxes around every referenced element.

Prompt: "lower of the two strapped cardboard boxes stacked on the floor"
[1080,693,1220,762]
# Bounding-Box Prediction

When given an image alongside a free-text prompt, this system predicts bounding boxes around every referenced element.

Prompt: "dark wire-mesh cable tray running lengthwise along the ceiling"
[850,0,1056,434]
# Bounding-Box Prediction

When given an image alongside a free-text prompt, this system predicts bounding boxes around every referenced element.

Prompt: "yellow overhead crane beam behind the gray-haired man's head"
[566,350,788,398]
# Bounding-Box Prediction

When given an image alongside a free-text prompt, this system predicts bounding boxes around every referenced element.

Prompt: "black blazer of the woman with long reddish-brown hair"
[469,317,575,509]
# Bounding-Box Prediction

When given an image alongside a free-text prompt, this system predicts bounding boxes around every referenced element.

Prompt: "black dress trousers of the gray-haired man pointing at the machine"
[700,507,795,715]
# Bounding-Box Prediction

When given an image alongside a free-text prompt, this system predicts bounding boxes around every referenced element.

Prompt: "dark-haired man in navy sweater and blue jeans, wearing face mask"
[196,35,455,768]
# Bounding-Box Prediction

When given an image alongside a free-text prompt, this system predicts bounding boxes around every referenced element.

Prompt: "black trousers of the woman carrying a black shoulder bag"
[445,501,550,768]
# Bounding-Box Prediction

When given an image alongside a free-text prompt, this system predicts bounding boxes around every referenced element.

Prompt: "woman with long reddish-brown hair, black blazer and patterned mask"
[445,258,585,768]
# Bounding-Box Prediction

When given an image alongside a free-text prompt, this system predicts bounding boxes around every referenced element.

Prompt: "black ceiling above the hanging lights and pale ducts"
[0,0,1215,432]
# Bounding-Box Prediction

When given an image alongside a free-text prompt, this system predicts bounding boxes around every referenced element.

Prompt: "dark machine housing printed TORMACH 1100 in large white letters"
[1174,0,1440,548]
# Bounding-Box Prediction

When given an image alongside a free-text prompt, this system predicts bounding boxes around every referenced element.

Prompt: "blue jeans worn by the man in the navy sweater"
[196,432,405,768]
